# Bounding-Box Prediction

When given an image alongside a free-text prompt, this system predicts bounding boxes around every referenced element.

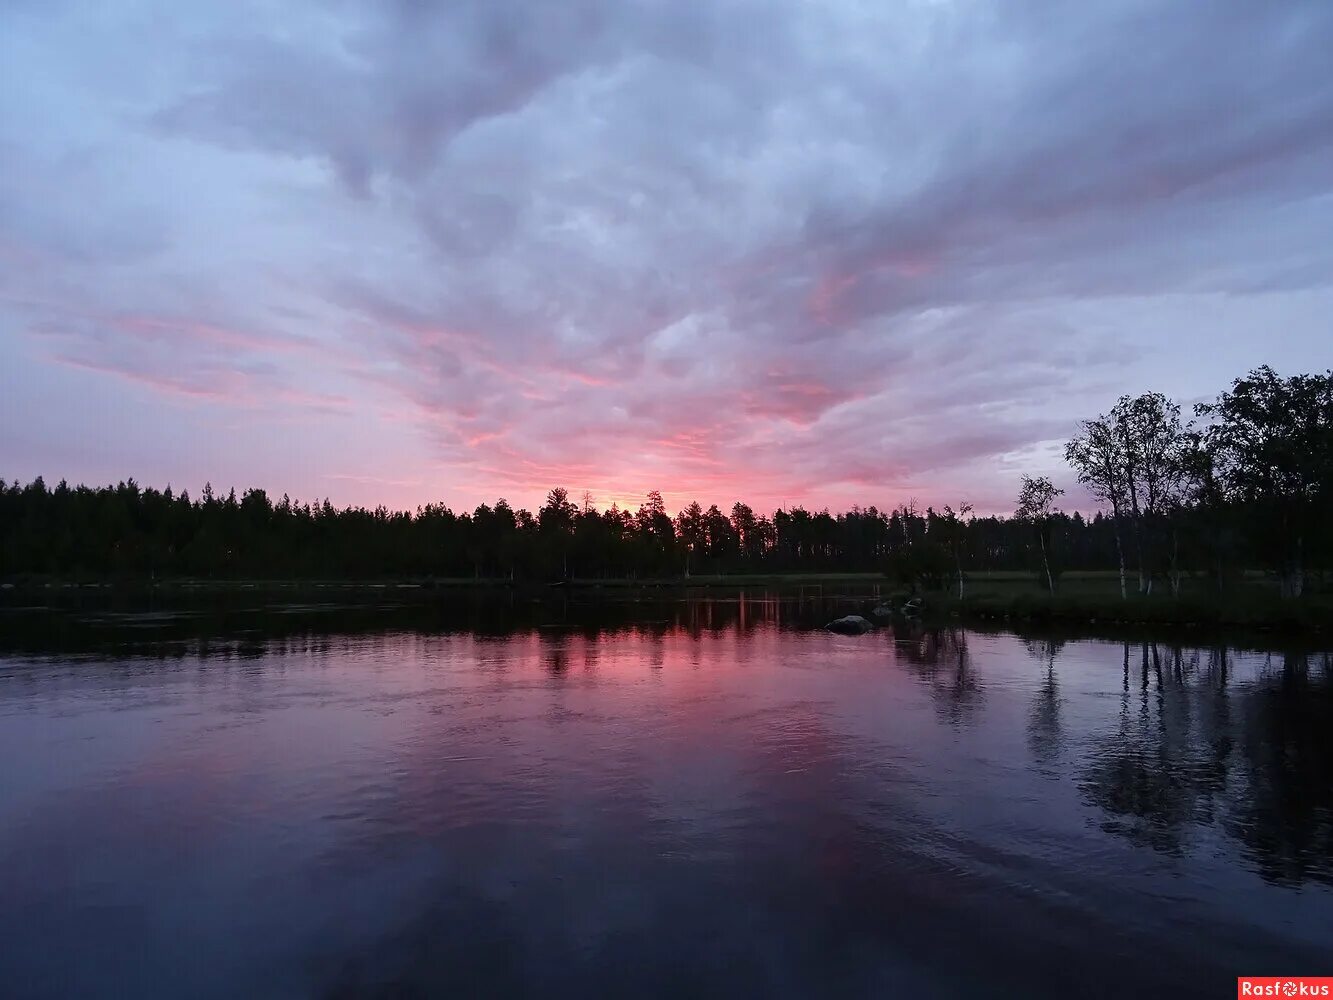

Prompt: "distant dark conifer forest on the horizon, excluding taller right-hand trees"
[0,479,1114,580]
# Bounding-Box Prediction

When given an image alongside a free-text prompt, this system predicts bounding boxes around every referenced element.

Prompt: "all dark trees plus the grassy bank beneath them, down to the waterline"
[0,367,1333,629]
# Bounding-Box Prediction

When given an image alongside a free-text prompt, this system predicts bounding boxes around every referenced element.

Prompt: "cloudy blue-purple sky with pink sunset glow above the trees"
[0,0,1333,512]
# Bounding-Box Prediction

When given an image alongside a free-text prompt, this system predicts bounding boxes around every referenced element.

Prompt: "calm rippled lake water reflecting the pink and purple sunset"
[0,601,1333,999]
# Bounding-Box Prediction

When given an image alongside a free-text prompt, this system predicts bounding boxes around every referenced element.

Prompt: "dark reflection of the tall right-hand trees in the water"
[1077,643,1333,884]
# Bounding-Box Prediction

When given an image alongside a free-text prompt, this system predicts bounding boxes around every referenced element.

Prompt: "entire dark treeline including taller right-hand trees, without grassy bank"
[0,368,1333,595]
